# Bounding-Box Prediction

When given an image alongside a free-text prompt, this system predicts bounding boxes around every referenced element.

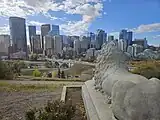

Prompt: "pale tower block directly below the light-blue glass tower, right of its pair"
[54,35,63,54]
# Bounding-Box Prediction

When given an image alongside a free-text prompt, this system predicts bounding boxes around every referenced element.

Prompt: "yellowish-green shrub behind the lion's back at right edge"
[132,62,160,79]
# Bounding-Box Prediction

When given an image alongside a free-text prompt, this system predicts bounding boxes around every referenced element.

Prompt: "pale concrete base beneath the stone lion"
[82,80,114,120]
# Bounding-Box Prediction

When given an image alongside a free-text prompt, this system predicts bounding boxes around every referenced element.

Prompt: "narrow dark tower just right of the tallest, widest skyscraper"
[28,26,36,51]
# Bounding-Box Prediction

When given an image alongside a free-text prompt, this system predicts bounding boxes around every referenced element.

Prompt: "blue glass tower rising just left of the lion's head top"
[96,29,106,49]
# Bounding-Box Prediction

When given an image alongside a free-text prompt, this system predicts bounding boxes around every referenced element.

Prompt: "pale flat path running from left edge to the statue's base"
[0,80,84,85]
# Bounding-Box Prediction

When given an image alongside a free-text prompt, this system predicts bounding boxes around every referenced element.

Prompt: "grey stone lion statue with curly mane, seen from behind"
[93,41,160,120]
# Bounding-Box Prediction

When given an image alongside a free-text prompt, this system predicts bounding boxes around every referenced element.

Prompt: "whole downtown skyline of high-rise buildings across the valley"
[0,17,159,59]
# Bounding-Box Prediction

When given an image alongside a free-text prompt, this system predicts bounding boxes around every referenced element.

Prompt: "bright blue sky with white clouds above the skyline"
[0,0,160,45]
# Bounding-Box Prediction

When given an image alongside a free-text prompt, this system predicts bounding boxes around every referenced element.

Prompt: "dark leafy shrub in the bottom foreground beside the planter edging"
[26,101,75,120]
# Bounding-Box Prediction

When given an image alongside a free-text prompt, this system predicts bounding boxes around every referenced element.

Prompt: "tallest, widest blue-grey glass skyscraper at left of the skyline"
[9,17,27,55]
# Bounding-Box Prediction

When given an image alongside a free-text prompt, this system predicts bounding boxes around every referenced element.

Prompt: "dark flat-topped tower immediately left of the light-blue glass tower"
[41,24,51,49]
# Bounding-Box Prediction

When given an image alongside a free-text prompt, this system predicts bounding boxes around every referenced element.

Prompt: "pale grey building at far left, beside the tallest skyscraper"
[0,35,10,54]
